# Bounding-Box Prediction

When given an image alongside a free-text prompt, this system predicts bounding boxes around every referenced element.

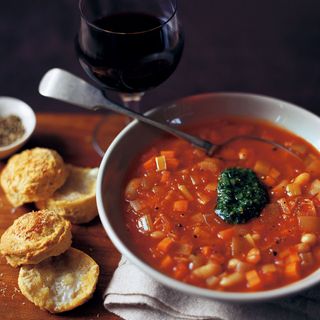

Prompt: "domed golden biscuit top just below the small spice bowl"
[0,148,68,207]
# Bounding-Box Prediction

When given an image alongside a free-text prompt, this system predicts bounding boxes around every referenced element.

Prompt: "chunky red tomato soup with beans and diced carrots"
[123,118,320,292]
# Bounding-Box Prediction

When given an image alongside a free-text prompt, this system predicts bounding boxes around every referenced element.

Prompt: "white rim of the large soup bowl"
[96,92,320,303]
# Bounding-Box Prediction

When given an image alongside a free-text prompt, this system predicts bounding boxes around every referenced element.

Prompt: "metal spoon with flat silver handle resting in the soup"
[39,68,299,158]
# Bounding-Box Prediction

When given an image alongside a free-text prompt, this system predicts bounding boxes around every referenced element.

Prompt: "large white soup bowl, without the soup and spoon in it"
[96,93,320,303]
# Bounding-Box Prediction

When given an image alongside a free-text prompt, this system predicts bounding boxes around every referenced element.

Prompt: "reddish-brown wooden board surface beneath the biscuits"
[0,113,126,320]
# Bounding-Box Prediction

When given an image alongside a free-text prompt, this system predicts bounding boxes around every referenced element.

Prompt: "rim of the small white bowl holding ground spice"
[0,96,37,152]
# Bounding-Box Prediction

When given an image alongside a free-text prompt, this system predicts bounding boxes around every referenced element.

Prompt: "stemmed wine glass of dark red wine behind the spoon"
[76,0,184,155]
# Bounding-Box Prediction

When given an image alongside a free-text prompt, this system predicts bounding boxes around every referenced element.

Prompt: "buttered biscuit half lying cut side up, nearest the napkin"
[18,248,99,313]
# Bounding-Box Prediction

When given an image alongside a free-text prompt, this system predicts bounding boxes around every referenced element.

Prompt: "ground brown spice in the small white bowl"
[0,115,25,147]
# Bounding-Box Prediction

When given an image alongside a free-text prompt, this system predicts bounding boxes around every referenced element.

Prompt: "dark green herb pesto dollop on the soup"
[215,168,269,224]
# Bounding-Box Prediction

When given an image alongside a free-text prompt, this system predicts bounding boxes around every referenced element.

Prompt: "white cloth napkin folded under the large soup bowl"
[104,258,320,320]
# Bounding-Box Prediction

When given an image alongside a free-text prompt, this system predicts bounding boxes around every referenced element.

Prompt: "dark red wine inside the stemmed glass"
[77,13,183,93]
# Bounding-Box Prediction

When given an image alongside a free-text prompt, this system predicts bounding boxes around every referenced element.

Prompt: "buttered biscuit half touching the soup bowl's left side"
[36,165,98,224]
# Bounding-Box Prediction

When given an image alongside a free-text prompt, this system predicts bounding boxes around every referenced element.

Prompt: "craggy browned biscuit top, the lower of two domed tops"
[0,210,72,267]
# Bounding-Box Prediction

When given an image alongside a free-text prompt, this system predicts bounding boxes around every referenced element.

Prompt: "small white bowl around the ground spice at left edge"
[0,97,36,159]
